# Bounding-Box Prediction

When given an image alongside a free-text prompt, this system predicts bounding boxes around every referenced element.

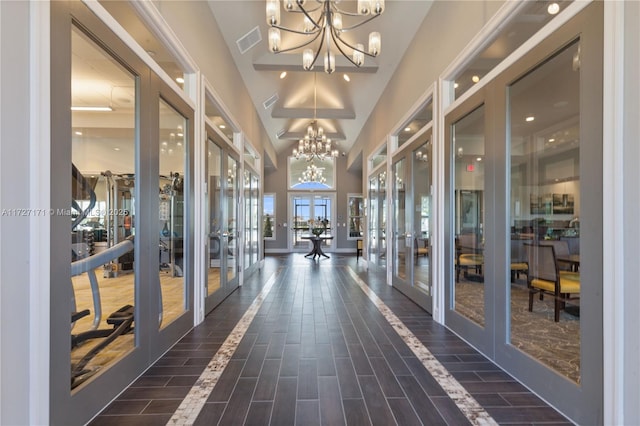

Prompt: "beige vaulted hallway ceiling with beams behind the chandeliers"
[209,0,432,170]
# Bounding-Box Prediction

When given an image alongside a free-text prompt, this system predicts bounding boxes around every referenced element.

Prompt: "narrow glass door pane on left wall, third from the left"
[206,139,223,296]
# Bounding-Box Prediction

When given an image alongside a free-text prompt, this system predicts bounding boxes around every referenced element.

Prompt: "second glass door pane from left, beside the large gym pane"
[158,99,187,327]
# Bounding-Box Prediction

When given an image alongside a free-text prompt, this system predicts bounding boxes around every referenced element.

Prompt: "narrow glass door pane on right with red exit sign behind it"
[451,105,485,325]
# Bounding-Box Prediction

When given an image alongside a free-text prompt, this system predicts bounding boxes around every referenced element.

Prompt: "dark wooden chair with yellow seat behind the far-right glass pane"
[525,244,580,322]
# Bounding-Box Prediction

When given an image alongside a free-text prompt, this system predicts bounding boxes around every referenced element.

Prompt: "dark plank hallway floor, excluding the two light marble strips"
[91,254,571,426]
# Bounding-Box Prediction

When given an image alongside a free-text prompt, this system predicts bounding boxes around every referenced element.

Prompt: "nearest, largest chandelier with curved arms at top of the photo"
[267,0,384,74]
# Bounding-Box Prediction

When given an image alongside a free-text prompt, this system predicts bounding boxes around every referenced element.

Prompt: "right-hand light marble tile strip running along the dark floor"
[347,268,497,425]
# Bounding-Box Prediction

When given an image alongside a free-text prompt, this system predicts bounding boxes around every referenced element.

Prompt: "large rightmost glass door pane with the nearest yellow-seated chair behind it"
[508,42,580,383]
